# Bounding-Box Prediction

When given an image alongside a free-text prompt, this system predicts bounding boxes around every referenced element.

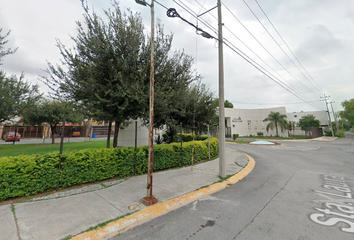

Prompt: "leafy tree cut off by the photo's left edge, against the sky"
[0,29,40,123]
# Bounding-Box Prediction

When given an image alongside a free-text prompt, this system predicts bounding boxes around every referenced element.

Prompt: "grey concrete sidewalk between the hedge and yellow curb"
[0,148,254,240]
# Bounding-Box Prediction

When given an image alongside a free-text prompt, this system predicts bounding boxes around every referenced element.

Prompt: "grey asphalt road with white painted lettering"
[115,138,354,240]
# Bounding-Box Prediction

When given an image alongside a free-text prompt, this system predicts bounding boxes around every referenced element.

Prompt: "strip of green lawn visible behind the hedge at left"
[0,140,112,157]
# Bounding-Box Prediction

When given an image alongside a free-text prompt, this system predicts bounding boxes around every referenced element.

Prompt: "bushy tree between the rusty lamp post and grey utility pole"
[141,22,216,142]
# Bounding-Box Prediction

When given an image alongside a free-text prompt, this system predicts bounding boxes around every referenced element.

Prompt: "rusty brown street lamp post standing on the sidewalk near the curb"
[135,0,158,206]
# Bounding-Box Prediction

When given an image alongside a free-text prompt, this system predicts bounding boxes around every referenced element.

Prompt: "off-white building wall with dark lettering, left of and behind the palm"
[225,107,287,137]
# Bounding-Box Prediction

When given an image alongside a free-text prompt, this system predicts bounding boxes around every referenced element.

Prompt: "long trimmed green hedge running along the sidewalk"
[0,137,219,200]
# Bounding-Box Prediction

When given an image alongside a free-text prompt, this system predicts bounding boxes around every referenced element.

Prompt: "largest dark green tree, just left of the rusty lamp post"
[43,1,148,147]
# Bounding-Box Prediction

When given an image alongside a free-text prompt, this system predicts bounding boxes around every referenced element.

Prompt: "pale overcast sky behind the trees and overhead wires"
[0,0,354,112]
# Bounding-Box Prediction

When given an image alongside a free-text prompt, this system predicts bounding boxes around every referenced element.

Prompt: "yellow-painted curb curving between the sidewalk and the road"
[71,153,256,240]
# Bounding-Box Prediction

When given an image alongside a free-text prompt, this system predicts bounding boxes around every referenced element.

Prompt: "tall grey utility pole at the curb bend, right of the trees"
[217,0,226,178]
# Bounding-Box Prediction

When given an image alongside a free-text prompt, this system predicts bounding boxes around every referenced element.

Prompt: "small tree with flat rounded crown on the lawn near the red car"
[22,99,85,144]
